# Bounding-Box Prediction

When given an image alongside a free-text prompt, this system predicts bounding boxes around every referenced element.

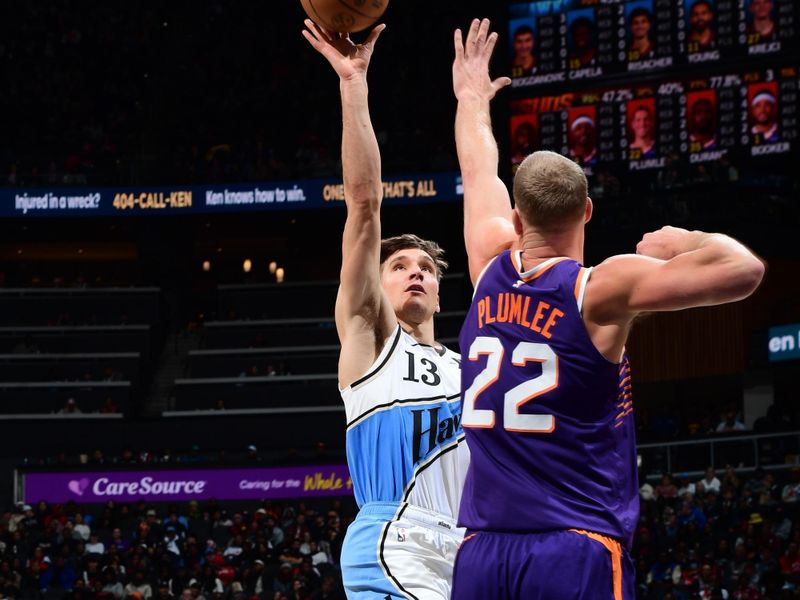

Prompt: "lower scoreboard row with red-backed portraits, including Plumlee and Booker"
[510,67,800,174]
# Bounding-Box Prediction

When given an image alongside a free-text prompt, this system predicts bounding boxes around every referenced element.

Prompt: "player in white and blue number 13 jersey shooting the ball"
[303,20,469,600]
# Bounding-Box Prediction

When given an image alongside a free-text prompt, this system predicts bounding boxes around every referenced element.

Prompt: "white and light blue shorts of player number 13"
[342,502,464,600]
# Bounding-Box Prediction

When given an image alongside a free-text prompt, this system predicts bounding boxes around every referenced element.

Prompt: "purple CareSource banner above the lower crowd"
[17,465,353,504]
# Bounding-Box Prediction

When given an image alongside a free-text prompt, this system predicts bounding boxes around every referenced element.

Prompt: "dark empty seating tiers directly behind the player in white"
[172,273,468,411]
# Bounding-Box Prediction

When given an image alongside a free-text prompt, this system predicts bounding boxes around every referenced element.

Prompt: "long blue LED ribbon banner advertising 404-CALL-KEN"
[0,173,463,218]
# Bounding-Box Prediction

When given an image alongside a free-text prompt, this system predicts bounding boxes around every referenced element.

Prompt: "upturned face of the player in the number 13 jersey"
[381,248,439,322]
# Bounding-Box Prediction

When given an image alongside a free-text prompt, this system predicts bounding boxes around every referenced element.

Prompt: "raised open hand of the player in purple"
[453,19,511,101]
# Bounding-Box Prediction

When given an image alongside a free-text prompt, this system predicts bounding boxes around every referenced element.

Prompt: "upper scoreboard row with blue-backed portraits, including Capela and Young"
[508,0,800,88]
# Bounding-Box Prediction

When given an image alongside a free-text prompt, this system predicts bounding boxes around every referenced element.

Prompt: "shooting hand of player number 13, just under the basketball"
[303,19,386,79]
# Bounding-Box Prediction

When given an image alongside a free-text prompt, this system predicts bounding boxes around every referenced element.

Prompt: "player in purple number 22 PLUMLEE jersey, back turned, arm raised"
[446,20,764,600]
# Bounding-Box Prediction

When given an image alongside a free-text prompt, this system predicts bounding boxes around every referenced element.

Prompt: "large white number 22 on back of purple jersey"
[461,336,558,433]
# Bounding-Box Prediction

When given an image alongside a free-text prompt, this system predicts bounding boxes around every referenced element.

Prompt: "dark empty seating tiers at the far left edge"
[0,288,161,418]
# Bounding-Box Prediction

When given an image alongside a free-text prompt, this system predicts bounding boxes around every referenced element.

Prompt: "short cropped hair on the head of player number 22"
[514,150,588,233]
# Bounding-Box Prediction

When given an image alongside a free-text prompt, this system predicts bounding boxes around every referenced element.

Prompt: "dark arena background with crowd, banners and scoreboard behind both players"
[0,0,800,600]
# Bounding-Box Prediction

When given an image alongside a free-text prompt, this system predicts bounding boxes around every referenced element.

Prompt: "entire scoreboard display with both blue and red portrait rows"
[509,0,800,174]
